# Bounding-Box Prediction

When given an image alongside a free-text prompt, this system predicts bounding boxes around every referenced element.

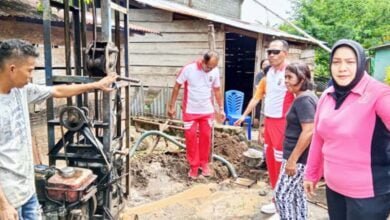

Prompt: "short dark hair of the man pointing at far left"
[0,39,39,68]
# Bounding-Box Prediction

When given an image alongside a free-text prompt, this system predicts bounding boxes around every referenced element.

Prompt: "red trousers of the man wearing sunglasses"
[264,117,286,189]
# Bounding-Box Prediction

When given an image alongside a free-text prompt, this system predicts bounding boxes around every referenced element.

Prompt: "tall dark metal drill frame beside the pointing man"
[43,0,130,219]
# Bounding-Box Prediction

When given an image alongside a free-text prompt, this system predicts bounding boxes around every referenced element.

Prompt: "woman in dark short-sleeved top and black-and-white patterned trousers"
[275,63,318,219]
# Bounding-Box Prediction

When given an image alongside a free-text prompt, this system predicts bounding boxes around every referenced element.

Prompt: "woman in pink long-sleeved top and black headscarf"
[304,40,390,220]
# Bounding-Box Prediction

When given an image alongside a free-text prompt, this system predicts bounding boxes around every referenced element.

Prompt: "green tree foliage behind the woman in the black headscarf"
[281,0,390,81]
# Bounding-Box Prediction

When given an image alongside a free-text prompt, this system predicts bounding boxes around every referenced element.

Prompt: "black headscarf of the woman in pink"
[330,39,366,109]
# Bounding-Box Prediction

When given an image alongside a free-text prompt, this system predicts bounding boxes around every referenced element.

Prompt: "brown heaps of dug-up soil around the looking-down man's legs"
[131,132,264,187]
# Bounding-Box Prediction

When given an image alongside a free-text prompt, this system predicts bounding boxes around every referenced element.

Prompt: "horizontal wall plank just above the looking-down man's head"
[129,42,224,54]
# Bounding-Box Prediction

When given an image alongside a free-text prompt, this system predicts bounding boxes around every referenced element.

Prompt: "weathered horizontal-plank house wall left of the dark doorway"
[129,9,225,87]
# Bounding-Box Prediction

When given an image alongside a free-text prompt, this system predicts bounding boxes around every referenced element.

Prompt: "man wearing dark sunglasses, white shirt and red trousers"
[261,40,294,214]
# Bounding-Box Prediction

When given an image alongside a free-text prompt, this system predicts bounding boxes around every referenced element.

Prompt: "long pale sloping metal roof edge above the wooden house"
[135,0,315,44]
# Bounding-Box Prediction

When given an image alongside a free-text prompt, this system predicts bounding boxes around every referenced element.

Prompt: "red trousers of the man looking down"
[183,113,214,168]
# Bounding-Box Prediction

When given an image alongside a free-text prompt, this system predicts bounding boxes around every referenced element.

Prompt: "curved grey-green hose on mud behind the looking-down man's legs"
[129,130,238,178]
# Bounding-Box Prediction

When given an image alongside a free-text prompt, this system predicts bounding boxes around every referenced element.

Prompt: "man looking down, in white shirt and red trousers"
[168,51,225,179]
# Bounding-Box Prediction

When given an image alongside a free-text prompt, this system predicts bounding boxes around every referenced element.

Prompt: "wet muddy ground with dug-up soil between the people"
[32,118,327,220]
